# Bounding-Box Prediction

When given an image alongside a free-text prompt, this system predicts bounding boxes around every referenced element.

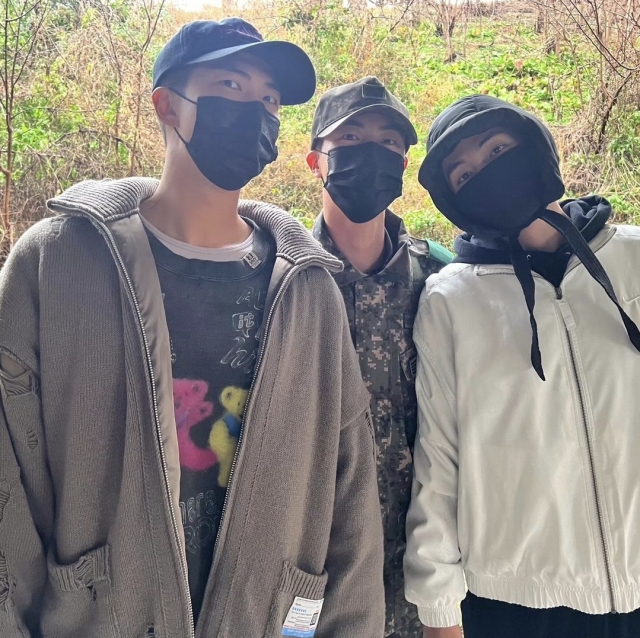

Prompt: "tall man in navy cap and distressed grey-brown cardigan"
[0,18,384,638]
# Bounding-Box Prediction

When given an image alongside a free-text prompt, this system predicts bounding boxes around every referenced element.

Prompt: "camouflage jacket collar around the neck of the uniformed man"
[312,210,412,286]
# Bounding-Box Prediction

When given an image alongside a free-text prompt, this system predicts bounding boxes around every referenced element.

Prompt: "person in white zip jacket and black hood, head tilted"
[405,96,640,638]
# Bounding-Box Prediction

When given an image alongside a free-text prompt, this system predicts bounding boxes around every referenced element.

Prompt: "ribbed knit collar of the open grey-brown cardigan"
[47,177,342,272]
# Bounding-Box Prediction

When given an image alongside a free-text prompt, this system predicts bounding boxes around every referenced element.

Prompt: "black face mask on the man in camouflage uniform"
[324,142,404,224]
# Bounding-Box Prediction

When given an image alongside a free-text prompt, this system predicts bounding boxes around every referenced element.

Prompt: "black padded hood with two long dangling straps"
[418,95,640,380]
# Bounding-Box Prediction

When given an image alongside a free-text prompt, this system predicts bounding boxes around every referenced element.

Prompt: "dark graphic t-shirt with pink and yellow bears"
[147,222,276,619]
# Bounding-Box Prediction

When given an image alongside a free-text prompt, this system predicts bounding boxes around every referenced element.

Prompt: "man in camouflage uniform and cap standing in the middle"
[307,77,451,638]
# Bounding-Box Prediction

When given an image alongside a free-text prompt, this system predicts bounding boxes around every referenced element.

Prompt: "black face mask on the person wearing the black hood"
[454,145,550,239]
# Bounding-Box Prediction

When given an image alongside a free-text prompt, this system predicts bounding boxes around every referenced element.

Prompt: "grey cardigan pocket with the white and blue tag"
[264,561,329,638]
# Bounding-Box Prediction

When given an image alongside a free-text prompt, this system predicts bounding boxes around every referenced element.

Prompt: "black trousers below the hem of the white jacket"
[462,592,640,638]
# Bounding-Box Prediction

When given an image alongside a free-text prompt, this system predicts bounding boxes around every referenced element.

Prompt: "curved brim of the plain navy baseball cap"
[187,40,316,106]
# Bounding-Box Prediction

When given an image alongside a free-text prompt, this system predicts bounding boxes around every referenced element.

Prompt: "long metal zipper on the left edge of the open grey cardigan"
[100,223,195,638]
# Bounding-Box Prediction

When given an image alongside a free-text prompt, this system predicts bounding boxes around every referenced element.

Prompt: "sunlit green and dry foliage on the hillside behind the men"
[0,0,640,252]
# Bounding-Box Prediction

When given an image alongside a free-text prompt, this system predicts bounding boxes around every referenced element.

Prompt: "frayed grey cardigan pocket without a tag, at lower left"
[42,545,120,638]
